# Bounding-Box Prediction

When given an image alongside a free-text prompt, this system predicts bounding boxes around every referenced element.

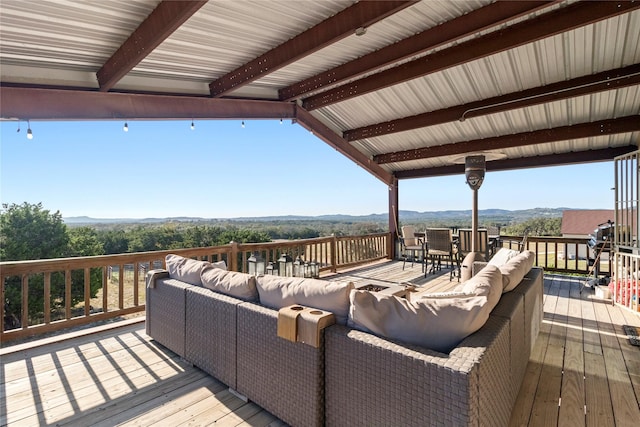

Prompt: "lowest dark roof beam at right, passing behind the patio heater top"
[395,145,638,179]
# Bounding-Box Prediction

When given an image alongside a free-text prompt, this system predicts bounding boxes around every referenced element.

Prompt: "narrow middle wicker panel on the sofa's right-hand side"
[491,292,529,406]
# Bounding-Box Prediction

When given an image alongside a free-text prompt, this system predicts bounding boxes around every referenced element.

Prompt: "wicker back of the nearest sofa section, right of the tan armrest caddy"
[325,322,490,426]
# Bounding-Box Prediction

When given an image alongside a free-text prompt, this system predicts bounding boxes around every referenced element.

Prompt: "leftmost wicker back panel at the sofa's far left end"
[146,279,193,357]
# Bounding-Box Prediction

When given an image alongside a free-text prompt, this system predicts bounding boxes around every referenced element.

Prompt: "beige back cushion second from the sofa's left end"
[200,265,258,302]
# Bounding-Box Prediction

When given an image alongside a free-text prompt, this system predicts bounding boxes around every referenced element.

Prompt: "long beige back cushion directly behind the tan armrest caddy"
[256,275,354,325]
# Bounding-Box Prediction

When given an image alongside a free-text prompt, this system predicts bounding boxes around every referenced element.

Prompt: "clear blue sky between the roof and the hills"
[0,120,614,218]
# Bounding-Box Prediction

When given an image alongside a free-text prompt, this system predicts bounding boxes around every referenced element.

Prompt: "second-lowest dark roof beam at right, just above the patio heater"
[373,115,640,164]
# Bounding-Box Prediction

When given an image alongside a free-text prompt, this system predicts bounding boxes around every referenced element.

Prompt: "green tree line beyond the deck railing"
[0,202,561,328]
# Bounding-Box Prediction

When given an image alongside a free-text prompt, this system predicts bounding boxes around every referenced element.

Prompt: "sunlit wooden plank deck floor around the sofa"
[0,262,640,427]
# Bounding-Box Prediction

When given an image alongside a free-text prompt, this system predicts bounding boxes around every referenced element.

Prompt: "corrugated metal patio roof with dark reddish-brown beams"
[0,0,640,187]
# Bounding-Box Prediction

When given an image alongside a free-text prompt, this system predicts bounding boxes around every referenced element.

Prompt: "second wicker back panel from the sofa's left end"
[185,287,242,389]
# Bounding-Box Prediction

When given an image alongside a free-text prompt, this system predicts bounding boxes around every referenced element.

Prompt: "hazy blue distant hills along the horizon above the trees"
[63,208,570,225]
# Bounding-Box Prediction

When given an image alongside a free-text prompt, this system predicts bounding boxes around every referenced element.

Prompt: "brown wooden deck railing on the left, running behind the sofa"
[0,233,391,342]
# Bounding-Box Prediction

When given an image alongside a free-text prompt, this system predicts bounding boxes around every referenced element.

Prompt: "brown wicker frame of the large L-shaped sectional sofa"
[146,252,543,426]
